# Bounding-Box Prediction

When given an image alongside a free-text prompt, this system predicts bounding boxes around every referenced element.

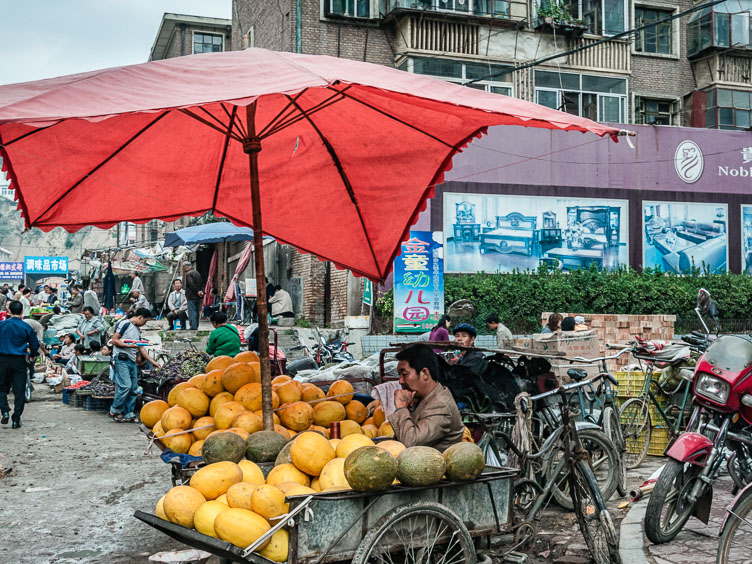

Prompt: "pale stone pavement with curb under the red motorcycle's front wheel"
[619,457,734,564]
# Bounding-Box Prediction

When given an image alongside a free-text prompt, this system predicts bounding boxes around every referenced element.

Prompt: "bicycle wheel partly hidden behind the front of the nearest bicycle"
[546,429,619,510]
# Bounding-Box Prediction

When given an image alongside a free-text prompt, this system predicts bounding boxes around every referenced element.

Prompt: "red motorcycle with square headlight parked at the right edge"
[645,290,752,543]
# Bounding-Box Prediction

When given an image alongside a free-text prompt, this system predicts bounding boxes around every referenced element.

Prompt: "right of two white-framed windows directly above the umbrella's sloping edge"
[535,71,627,123]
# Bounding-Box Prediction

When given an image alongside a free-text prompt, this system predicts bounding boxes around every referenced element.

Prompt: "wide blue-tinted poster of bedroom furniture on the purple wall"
[444,193,629,273]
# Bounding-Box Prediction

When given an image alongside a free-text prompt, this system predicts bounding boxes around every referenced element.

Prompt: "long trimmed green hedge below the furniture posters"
[377,267,752,333]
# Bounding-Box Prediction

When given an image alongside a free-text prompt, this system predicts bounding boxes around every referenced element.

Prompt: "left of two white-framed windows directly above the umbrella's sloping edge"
[408,57,512,96]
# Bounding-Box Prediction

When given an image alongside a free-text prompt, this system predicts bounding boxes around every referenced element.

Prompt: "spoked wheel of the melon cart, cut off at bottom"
[352,502,478,564]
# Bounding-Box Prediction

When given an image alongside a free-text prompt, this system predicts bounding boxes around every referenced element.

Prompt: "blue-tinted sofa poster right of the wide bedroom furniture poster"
[642,201,728,274]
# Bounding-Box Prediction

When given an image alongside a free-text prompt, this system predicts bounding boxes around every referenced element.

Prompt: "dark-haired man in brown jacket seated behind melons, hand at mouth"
[388,344,464,451]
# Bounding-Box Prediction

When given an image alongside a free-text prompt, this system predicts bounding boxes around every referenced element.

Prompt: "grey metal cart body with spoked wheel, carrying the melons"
[134,466,517,564]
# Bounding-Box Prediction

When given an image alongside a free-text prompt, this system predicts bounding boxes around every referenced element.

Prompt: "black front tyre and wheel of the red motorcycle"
[645,460,702,544]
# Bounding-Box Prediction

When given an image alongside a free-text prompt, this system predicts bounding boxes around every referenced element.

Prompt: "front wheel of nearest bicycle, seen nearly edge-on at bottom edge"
[569,460,621,564]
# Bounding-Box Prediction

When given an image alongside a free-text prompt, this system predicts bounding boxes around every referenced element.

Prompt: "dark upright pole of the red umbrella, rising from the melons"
[243,101,274,431]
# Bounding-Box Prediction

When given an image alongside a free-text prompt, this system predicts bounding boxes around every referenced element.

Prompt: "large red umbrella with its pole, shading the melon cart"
[0,49,619,428]
